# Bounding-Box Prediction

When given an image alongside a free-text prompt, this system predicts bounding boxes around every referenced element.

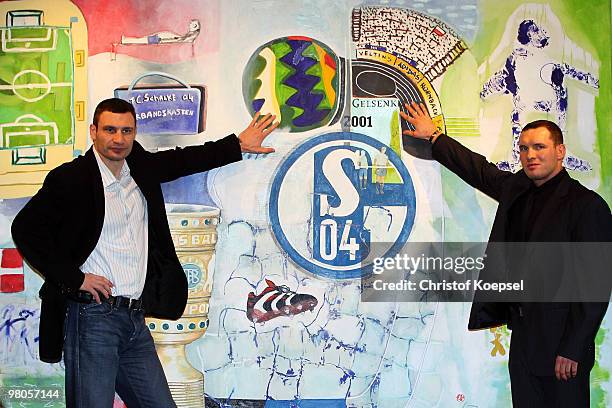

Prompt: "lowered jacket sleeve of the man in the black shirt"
[557,195,612,361]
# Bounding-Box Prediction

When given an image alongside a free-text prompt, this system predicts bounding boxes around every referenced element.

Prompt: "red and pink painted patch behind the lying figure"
[72,0,219,63]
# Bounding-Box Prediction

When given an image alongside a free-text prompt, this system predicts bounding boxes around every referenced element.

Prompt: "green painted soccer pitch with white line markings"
[0,28,73,147]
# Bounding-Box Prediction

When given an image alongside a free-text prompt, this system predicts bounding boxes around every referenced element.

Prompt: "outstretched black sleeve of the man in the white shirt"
[146,134,242,183]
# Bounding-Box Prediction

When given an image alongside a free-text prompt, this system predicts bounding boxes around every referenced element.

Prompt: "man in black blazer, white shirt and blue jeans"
[12,98,278,408]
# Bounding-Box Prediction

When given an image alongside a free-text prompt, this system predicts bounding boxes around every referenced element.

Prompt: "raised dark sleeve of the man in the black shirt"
[432,134,512,201]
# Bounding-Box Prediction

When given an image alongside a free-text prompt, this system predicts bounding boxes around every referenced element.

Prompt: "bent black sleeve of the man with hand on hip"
[11,171,85,294]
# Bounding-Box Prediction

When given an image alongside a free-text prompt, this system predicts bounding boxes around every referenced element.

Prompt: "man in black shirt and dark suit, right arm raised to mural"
[401,103,612,407]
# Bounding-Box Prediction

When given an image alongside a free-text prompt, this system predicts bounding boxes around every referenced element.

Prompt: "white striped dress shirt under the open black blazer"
[81,148,148,299]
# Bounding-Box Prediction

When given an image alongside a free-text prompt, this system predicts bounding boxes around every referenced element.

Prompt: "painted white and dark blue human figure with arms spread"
[480,20,599,171]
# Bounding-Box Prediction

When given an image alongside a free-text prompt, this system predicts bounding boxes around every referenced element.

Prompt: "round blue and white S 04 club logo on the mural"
[269,132,416,279]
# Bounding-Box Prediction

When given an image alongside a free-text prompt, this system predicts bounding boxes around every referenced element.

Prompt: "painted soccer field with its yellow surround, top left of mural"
[0,0,87,198]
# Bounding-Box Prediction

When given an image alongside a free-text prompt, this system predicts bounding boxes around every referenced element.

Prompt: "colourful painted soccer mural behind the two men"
[0,0,612,407]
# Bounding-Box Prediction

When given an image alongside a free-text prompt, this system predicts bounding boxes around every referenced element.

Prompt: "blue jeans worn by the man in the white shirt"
[64,300,176,408]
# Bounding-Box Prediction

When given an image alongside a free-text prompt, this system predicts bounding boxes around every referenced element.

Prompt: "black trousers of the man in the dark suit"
[508,346,590,408]
